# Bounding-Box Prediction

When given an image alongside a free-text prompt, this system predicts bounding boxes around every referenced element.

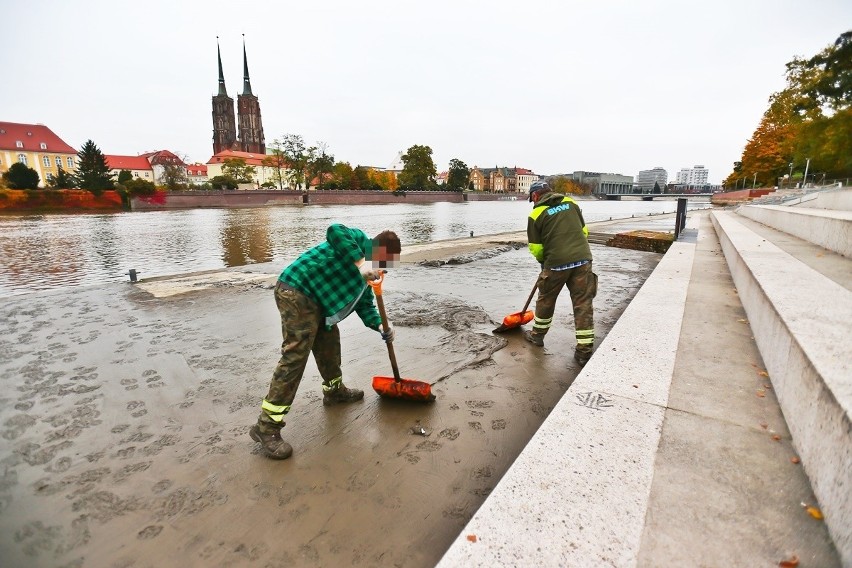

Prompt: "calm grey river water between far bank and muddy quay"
[0,200,708,297]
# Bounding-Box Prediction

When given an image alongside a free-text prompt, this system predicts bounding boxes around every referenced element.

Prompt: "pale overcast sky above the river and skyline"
[0,0,852,183]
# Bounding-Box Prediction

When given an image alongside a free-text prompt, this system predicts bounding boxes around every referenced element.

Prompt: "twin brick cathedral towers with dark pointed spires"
[213,38,266,154]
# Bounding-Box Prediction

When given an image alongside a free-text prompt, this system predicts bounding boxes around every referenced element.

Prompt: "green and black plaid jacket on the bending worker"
[278,224,381,329]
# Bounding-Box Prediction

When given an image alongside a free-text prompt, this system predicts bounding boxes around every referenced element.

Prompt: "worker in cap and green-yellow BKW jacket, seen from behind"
[524,181,598,367]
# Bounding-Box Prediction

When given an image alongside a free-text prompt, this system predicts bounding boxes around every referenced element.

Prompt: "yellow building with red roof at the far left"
[0,122,77,187]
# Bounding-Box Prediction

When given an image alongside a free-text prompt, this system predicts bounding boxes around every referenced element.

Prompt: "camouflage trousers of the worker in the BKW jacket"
[532,262,598,355]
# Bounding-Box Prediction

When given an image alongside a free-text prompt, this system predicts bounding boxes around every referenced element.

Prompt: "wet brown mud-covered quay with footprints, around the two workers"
[0,237,660,568]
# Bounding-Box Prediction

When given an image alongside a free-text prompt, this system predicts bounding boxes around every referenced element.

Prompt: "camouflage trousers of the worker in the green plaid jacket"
[257,282,342,433]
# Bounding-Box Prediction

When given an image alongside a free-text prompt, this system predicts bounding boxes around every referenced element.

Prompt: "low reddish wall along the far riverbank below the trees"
[131,190,526,211]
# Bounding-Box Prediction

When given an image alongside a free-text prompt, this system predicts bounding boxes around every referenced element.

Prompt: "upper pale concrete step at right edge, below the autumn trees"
[737,205,852,258]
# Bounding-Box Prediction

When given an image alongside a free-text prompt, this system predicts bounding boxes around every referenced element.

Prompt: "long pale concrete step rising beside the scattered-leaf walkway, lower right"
[711,211,852,565]
